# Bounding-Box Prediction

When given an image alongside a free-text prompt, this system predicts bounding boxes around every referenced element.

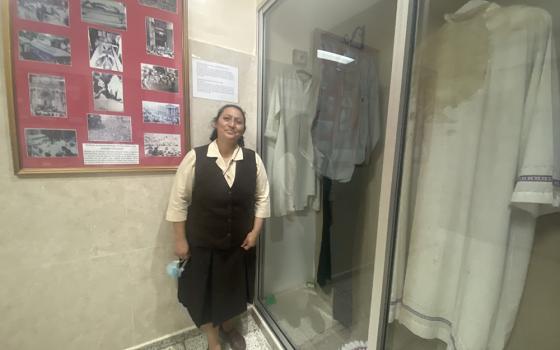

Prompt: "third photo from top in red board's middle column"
[92,72,124,112]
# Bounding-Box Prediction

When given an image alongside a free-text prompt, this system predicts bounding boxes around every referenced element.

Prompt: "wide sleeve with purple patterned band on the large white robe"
[511,13,560,215]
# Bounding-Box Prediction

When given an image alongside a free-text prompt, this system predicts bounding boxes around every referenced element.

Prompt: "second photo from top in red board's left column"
[18,30,72,65]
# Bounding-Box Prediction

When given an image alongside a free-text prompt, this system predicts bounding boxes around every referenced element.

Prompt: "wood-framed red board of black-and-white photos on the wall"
[1,0,190,175]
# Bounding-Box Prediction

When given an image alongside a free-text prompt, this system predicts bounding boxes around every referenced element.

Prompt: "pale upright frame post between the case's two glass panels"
[368,0,419,350]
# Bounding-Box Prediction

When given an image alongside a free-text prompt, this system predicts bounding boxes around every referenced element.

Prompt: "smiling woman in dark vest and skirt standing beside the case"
[166,105,270,350]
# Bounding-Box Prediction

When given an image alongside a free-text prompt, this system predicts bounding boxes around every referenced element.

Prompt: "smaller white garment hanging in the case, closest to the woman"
[265,69,321,216]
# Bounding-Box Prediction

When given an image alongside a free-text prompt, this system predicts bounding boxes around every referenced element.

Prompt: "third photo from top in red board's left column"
[29,74,67,118]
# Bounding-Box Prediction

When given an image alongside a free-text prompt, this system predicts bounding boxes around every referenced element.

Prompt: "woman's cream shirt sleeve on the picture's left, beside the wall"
[165,150,196,222]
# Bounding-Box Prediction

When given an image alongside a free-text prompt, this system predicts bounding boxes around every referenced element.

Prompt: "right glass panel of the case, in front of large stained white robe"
[385,0,560,350]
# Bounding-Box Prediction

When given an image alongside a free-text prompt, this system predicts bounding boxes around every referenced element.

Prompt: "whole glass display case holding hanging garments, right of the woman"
[257,0,560,350]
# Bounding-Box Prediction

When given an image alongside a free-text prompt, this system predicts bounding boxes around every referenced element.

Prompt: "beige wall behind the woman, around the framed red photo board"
[0,0,256,350]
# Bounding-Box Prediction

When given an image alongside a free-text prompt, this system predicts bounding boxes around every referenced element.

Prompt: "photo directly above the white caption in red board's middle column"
[88,113,132,142]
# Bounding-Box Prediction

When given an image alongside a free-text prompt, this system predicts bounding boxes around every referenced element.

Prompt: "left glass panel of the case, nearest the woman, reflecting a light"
[260,0,396,349]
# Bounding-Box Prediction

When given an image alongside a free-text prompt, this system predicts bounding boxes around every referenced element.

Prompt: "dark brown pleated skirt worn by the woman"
[177,247,256,327]
